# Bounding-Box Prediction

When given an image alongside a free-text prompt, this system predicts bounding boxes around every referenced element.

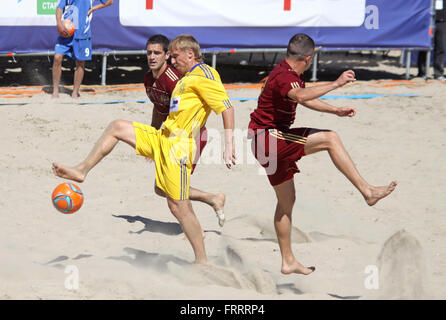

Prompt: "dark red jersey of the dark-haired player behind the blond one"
[144,65,181,115]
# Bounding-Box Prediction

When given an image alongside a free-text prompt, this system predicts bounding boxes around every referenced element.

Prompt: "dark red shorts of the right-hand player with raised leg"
[251,128,312,186]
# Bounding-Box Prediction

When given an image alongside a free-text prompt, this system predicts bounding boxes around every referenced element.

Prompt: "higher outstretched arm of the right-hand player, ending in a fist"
[287,70,356,104]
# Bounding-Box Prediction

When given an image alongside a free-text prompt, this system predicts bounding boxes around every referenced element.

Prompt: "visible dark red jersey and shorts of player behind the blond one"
[144,65,208,173]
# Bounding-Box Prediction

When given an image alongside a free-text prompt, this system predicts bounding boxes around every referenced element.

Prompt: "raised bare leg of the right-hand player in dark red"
[305,131,397,206]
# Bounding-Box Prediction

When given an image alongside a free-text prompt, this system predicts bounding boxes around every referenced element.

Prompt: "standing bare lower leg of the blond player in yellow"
[167,197,208,264]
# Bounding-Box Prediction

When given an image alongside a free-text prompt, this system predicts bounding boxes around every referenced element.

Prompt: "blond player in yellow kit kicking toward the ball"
[53,35,235,263]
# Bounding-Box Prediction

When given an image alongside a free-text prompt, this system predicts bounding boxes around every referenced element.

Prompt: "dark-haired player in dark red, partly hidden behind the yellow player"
[144,34,225,227]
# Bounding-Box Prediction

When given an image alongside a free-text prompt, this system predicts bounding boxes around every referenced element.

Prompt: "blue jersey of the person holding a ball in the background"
[57,0,107,39]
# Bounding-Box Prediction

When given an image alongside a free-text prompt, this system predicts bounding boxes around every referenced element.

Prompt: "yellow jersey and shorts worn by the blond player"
[134,59,232,200]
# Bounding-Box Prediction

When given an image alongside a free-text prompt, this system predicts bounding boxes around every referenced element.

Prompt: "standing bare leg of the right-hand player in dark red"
[274,179,315,275]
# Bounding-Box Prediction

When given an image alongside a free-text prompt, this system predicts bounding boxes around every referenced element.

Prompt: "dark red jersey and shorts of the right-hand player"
[248,60,311,186]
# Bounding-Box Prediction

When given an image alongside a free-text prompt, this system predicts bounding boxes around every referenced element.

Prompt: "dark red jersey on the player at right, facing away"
[249,60,305,134]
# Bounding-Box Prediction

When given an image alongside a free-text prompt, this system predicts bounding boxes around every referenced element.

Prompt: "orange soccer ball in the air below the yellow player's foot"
[51,182,84,214]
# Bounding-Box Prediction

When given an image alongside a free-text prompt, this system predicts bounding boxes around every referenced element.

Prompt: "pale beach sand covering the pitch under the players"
[0,65,446,300]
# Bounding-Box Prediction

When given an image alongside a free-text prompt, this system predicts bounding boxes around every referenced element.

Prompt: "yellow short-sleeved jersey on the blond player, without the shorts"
[163,63,232,138]
